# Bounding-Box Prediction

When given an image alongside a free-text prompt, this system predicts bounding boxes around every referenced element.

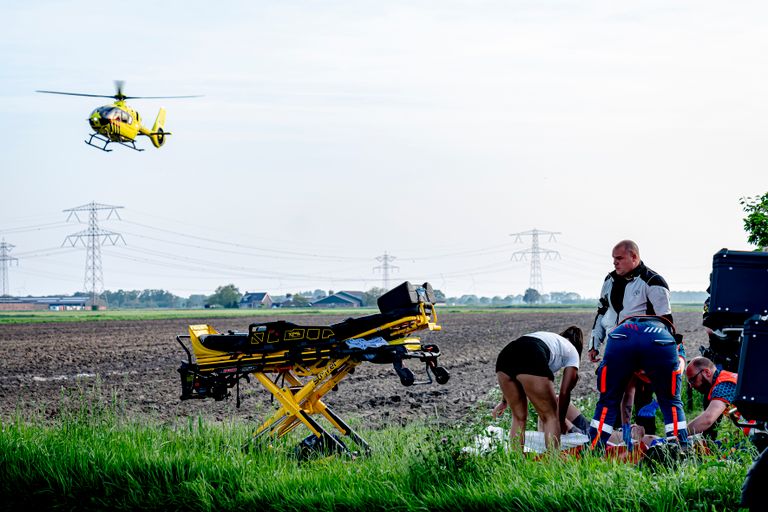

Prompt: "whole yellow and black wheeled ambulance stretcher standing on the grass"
[176,281,450,453]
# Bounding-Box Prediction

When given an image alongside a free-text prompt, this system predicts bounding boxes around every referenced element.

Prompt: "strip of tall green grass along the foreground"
[0,388,750,512]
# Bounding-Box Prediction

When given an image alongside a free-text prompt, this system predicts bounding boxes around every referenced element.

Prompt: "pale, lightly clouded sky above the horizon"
[0,0,768,297]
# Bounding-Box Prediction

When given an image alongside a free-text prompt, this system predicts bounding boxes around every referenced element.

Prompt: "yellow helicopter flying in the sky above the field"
[36,80,199,151]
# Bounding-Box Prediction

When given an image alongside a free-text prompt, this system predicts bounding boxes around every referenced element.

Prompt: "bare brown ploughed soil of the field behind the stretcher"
[0,312,706,426]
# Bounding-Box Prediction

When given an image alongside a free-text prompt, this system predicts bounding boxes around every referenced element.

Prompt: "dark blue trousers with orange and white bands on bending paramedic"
[589,316,688,448]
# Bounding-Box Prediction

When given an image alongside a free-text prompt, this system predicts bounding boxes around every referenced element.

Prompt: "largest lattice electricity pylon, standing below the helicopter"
[61,201,125,306]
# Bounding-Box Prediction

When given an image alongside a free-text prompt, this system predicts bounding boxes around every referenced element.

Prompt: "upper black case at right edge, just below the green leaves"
[703,249,768,329]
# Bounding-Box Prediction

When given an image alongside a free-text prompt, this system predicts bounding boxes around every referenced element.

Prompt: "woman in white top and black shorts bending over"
[493,325,584,449]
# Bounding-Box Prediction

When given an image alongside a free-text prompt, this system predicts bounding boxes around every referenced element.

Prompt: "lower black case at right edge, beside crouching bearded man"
[733,316,768,421]
